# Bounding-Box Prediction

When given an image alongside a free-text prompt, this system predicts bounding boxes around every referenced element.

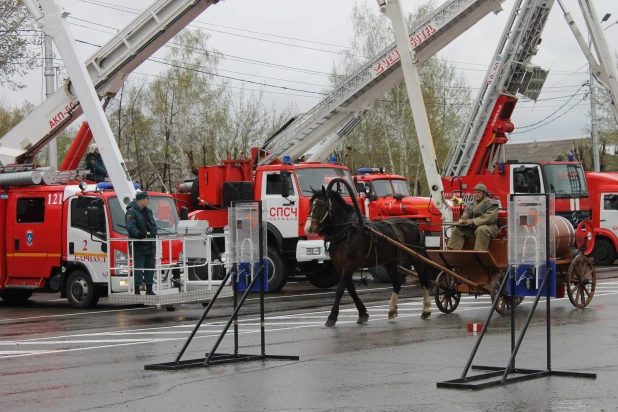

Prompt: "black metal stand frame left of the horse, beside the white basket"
[144,201,300,370]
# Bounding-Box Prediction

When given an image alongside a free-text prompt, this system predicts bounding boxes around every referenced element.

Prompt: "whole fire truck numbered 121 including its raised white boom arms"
[0,0,217,308]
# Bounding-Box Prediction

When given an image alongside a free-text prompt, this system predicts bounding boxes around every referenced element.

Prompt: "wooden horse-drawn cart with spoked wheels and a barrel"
[427,216,596,315]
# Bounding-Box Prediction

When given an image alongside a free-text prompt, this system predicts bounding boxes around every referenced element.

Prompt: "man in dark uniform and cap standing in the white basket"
[124,192,157,295]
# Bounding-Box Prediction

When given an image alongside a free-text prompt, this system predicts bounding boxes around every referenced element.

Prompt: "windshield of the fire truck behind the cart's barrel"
[543,164,588,199]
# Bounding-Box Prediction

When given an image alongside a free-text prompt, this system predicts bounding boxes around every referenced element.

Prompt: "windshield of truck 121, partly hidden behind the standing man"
[109,196,180,235]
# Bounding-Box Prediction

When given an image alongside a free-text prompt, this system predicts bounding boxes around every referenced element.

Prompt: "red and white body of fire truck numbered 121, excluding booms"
[0,173,182,308]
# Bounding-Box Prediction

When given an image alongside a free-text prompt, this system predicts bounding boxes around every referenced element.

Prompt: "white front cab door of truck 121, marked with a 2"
[65,196,109,283]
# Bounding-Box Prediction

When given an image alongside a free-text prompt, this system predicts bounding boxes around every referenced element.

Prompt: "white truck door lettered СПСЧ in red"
[262,172,298,238]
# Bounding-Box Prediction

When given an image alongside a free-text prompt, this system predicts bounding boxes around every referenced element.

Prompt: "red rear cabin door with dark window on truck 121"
[6,193,48,278]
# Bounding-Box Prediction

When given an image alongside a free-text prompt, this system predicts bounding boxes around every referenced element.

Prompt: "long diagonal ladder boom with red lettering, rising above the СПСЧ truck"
[259,0,504,165]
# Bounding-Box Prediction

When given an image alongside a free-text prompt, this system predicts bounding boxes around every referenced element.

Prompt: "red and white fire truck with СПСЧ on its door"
[174,154,356,292]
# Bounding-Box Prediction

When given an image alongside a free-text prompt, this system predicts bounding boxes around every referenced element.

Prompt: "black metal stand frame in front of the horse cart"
[436,194,597,390]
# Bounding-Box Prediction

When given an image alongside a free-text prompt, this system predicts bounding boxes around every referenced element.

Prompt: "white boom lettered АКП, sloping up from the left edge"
[0,0,219,165]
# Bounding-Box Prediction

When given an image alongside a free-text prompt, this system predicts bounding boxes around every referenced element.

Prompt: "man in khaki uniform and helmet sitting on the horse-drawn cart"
[448,183,498,250]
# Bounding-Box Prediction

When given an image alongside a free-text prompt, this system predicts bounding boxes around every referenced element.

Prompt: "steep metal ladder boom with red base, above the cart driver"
[444,0,554,176]
